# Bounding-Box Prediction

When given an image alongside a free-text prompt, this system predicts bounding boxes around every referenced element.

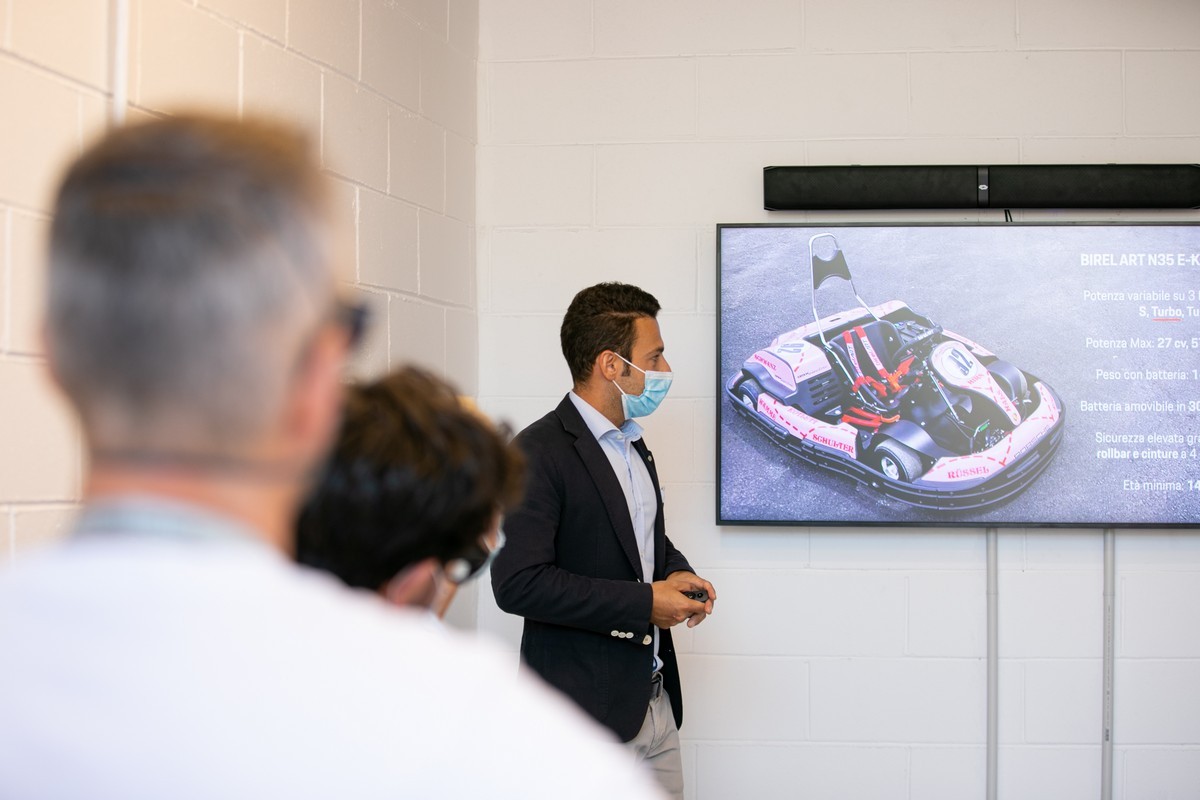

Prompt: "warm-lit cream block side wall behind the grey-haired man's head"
[0,0,479,569]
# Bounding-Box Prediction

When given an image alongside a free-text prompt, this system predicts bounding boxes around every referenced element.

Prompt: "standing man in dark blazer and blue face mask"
[492,283,716,798]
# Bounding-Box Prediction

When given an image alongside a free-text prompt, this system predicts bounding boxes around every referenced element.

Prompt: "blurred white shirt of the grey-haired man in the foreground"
[0,499,661,800]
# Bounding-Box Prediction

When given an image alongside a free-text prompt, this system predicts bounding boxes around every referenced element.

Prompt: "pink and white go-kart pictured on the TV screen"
[725,234,1064,510]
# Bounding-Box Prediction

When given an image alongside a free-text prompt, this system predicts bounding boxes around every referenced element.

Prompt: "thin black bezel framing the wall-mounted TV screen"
[713,218,1200,530]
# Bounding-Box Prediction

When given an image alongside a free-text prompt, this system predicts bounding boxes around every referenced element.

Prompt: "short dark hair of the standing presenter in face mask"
[559,283,661,385]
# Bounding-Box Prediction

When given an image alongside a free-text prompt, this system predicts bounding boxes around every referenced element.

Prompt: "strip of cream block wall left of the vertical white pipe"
[0,0,109,569]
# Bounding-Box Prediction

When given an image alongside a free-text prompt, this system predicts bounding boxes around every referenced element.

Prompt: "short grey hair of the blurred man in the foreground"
[47,116,334,451]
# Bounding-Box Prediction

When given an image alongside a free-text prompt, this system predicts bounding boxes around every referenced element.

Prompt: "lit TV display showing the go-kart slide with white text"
[716,223,1200,528]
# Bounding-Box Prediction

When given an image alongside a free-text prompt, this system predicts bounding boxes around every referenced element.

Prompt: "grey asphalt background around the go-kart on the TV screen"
[718,225,1200,527]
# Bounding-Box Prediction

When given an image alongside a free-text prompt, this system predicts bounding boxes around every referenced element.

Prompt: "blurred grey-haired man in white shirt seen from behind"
[0,116,656,800]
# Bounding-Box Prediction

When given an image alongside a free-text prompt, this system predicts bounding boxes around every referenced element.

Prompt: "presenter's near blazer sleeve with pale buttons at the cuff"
[492,435,654,643]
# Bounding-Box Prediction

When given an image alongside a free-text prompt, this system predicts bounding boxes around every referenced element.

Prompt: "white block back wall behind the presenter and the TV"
[478,0,1200,800]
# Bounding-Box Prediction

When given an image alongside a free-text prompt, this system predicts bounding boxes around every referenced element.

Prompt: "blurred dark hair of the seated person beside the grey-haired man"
[296,367,524,590]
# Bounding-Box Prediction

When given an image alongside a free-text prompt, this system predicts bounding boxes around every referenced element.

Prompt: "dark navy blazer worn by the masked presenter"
[492,396,692,741]
